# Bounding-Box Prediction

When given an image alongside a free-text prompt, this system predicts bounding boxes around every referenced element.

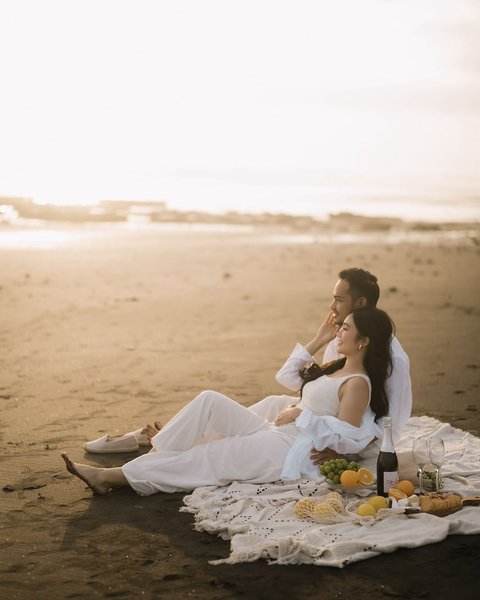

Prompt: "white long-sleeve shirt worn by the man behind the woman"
[275,337,412,441]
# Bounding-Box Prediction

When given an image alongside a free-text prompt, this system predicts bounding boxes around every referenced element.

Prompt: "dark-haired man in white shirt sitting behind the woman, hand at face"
[250,268,412,464]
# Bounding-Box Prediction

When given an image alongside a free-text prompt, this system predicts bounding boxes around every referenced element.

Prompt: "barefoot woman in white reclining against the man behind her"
[62,308,392,495]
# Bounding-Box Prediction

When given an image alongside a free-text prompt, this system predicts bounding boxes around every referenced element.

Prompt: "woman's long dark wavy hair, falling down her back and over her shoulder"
[299,307,394,420]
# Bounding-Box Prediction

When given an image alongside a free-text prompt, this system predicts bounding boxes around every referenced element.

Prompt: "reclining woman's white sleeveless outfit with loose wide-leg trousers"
[122,376,376,496]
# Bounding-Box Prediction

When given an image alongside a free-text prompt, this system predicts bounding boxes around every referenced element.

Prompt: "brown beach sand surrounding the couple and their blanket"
[0,225,480,600]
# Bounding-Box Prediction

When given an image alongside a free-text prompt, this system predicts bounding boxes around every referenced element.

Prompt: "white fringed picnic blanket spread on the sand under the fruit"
[180,417,480,567]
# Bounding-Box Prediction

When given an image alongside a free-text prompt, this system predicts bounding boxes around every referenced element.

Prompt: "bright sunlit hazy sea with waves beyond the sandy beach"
[0,172,480,248]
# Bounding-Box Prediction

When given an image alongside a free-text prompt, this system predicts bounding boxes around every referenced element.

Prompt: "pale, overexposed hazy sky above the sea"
[0,0,480,213]
